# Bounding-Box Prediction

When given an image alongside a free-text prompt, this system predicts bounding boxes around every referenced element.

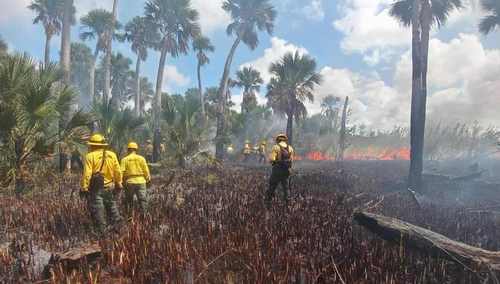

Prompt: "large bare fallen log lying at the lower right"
[354,212,500,272]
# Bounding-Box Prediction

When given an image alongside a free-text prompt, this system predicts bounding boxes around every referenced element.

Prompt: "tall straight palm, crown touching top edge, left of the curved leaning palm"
[144,0,201,162]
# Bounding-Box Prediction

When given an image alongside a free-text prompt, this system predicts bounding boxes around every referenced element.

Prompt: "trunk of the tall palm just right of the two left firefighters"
[153,47,167,163]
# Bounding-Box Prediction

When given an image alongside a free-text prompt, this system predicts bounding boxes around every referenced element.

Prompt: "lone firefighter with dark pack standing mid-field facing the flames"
[265,134,294,207]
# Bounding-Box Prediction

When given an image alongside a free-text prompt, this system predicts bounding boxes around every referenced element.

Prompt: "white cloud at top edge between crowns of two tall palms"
[191,0,231,34]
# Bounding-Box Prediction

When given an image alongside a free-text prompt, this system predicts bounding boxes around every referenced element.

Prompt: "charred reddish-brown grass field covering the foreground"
[0,161,500,283]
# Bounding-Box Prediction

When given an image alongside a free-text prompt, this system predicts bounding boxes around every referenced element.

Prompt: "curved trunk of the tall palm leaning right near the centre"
[215,37,241,161]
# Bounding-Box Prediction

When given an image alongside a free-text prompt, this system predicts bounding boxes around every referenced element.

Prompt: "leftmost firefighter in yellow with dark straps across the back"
[80,134,123,235]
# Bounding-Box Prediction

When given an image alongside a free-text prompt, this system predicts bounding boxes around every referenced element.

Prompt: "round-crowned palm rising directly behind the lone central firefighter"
[267,51,322,144]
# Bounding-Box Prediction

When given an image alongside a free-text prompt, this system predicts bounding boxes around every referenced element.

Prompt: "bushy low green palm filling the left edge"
[0,56,88,192]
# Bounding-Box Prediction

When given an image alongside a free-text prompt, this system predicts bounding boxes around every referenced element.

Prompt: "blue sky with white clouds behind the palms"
[0,0,500,130]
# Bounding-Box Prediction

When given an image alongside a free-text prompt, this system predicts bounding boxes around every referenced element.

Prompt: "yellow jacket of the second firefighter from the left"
[121,152,151,184]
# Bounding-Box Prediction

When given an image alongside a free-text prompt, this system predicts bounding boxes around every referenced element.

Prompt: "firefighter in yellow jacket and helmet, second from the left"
[121,142,151,213]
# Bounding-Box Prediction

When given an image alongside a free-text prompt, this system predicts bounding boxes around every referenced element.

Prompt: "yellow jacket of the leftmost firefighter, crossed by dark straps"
[82,149,122,191]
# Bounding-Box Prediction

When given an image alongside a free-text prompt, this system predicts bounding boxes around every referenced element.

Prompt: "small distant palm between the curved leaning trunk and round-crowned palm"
[235,67,264,114]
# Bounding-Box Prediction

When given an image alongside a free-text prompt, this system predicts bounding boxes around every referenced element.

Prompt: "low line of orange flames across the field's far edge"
[296,147,410,161]
